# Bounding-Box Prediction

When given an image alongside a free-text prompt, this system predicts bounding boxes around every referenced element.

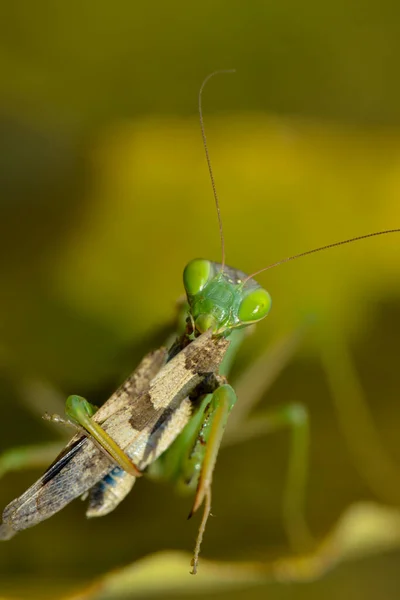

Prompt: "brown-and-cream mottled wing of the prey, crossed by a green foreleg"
[0,332,229,539]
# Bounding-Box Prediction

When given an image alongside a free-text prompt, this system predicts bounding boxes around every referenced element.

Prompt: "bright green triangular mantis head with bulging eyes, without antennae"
[183,259,271,335]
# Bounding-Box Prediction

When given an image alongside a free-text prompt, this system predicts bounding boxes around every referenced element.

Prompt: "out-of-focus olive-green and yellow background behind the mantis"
[0,0,400,600]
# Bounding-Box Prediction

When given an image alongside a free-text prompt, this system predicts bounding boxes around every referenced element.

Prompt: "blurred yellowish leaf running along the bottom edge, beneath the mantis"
[57,503,400,600]
